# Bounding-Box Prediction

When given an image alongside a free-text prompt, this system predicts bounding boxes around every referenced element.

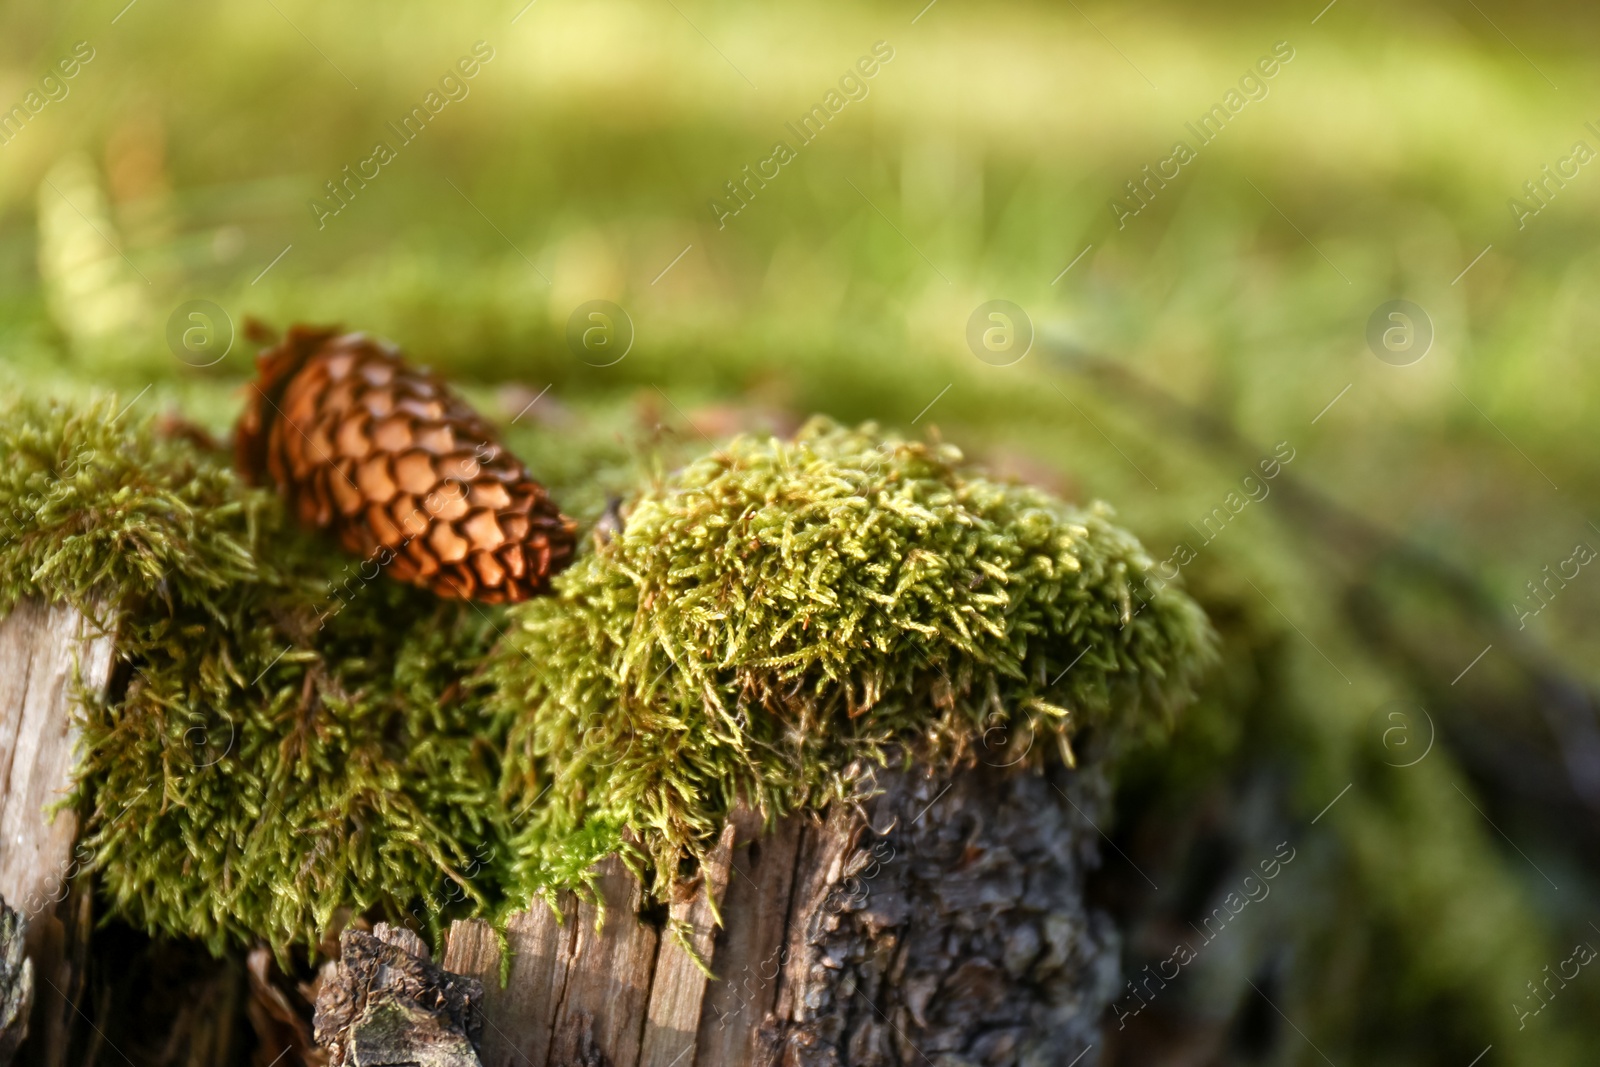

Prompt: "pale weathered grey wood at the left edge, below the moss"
[0,600,114,1067]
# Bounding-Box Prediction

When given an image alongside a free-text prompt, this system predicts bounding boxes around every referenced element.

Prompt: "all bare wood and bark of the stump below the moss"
[0,601,1118,1067]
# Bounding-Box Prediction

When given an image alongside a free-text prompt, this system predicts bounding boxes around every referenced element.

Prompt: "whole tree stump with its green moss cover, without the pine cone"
[0,410,1211,1067]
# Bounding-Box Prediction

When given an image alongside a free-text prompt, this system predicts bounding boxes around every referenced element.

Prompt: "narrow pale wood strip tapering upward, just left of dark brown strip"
[638,822,738,1067]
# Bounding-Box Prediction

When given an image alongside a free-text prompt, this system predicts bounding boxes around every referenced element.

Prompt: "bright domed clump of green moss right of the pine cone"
[490,421,1211,897]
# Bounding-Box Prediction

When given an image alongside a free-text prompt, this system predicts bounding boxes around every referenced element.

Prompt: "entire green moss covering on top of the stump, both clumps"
[0,403,1210,953]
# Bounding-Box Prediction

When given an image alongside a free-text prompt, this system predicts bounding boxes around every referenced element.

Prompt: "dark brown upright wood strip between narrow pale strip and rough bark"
[685,808,806,1067]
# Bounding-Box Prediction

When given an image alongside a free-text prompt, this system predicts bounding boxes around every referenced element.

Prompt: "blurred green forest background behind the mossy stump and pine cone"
[0,0,1600,1067]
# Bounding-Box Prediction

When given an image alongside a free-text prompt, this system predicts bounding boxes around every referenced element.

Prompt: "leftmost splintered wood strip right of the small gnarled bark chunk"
[443,896,576,1067]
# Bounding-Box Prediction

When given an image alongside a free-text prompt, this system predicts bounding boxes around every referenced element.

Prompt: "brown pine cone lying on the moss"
[234,326,576,603]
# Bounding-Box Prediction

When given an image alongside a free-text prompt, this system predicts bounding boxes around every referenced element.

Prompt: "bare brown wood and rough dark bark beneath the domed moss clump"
[443,763,1118,1067]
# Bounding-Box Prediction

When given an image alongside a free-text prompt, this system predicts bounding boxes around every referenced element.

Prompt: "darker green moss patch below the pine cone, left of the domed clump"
[0,403,501,950]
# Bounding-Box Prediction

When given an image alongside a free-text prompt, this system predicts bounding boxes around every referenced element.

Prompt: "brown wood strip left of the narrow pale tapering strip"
[550,856,658,1067]
